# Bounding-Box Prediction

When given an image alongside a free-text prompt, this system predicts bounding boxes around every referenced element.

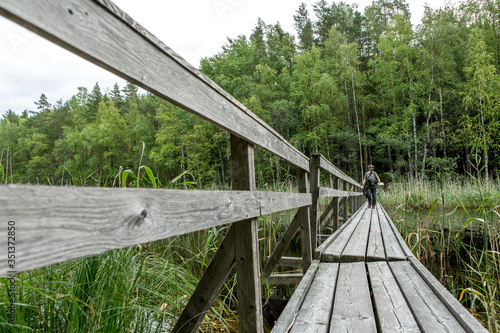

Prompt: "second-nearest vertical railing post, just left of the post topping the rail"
[297,168,313,274]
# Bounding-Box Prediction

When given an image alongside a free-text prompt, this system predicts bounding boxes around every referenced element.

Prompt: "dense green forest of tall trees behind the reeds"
[0,0,500,188]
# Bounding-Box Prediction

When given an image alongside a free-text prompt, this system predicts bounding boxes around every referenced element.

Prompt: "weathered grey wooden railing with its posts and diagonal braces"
[0,0,360,333]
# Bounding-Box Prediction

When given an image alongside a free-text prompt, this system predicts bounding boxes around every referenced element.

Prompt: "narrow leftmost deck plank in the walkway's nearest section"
[271,260,319,333]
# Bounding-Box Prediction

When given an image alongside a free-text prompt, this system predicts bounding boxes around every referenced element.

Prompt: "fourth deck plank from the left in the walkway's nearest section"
[367,262,420,333]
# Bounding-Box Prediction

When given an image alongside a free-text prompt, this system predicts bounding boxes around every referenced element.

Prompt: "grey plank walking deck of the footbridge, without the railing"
[272,205,487,333]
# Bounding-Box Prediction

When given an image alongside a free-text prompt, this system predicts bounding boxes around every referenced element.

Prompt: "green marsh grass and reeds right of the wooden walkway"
[381,178,500,333]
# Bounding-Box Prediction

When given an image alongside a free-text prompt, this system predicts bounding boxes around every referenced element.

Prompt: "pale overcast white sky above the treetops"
[0,0,452,114]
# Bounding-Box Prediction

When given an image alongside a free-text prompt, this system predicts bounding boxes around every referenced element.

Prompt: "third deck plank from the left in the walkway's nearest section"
[330,262,377,333]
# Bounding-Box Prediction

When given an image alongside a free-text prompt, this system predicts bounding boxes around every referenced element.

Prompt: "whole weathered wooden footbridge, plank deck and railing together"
[0,0,486,333]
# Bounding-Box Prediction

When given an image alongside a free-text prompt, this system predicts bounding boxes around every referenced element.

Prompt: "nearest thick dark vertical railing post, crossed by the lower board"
[231,134,264,333]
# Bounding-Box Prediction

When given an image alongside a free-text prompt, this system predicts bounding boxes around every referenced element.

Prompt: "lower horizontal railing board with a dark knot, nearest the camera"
[0,185,311,274]
